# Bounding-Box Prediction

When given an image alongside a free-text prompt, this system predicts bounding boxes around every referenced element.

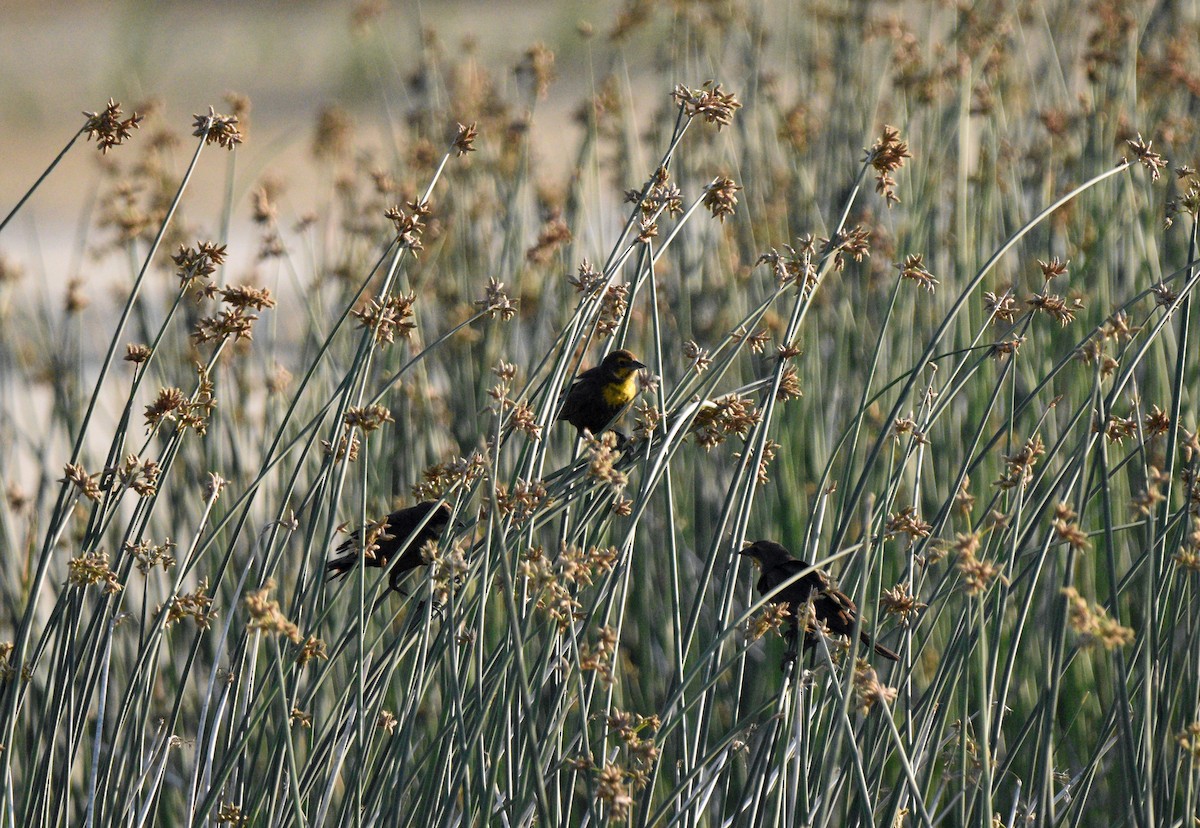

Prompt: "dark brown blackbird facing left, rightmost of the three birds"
[742,540,900,661]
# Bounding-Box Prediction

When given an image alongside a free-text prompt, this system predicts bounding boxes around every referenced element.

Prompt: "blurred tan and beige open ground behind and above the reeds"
[0,0,633,280]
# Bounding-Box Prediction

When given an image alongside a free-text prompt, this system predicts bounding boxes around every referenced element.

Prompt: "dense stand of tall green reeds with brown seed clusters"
[0,2,1200,828]
